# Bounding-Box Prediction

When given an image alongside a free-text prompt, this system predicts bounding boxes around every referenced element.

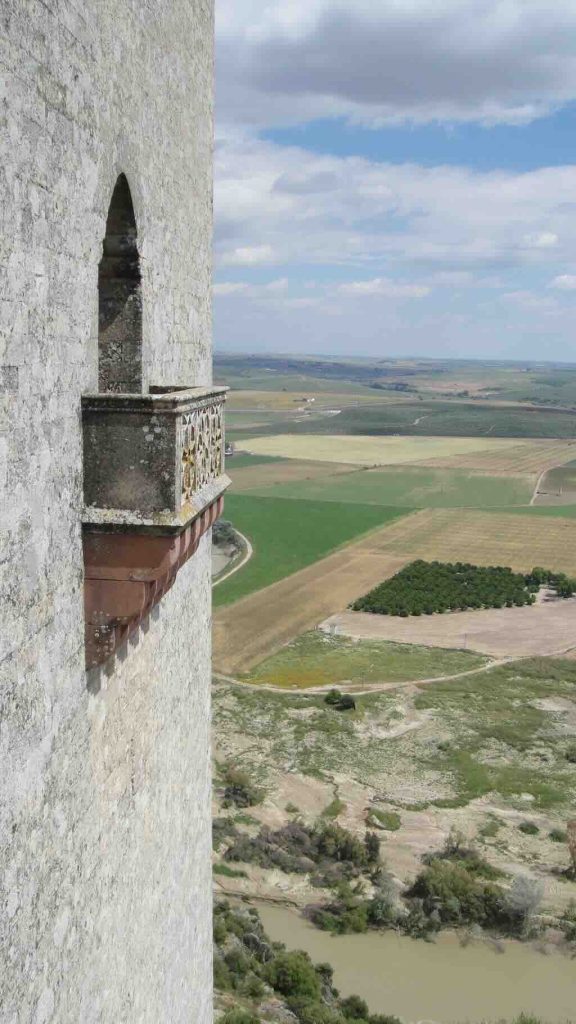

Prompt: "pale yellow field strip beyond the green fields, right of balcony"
[242,434,518,466]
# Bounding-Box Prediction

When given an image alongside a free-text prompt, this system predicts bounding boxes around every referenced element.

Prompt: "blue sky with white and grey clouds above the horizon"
[214,0,576,361]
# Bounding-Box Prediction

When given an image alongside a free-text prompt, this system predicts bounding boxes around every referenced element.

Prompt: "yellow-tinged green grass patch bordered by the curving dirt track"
[243,630,487,689]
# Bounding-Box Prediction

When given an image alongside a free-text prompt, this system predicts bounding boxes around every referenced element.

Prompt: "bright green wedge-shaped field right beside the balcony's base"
[213,494,411,606]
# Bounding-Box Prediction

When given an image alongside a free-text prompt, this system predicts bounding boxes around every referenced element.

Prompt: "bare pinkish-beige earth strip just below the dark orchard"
[322,598,576,657]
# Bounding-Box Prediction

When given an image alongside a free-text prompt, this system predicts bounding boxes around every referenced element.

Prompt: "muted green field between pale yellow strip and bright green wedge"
[239,463,533,508]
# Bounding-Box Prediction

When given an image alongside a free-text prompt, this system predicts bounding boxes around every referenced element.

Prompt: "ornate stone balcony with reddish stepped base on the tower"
[82,387,230,669]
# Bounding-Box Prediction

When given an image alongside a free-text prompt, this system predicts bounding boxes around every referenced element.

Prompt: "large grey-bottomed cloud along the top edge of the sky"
[216,0,576,125]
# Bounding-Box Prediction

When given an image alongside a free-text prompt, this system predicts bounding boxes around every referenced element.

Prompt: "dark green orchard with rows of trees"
[352,559,576,616]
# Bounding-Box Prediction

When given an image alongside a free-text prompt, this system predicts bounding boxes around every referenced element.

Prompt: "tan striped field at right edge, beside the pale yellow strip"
[412,440,576,476]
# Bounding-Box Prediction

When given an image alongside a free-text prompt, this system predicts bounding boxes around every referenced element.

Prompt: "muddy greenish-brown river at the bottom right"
[258,904,576,1024]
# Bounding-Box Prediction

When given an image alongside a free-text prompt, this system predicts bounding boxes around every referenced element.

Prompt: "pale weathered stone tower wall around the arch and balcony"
[0,0,213,1024]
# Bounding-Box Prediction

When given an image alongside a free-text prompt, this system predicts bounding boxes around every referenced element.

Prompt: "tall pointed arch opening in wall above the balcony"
[98,174,142,394]
